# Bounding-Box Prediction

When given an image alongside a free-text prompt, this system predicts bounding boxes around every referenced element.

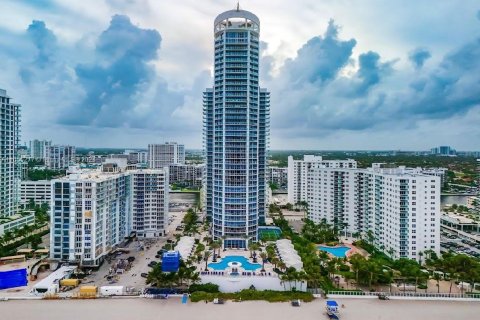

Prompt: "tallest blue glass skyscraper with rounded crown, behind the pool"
[203,7,270,248]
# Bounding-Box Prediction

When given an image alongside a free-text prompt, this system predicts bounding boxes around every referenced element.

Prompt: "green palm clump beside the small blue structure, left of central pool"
[146,260,200,288]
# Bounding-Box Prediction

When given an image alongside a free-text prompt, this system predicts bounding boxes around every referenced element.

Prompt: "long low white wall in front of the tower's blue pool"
[201,275,307,292]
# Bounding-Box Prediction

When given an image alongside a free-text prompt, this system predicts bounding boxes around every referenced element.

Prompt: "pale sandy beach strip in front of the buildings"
[0,298,480,320]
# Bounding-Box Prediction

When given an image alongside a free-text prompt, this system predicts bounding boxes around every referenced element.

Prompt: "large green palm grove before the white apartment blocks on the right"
[274,202,480,292]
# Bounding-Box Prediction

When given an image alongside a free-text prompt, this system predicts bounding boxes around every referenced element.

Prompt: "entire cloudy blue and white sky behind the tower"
[0,0,480,150]
